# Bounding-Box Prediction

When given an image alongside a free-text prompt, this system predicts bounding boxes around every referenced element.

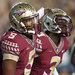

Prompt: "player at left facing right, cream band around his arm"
[0,2,38,75]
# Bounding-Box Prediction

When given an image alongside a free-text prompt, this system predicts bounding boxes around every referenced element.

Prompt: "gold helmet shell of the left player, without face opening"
[9,2,37,33]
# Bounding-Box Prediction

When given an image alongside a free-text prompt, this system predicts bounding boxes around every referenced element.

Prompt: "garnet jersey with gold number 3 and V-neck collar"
[30,33,69,75]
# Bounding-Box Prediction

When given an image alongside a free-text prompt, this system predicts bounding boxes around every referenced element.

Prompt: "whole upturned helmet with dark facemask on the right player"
[43,9,73,37]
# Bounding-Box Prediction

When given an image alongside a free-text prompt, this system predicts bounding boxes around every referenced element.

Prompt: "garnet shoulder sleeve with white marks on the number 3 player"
[36,32,48,53]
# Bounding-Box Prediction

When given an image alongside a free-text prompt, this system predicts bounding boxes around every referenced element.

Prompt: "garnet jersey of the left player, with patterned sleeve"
[1,31,35,75]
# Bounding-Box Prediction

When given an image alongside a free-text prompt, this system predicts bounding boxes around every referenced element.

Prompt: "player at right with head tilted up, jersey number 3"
[30,8,73,75]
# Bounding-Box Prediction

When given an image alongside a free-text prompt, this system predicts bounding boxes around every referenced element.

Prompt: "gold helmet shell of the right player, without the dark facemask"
[43,8,66,33]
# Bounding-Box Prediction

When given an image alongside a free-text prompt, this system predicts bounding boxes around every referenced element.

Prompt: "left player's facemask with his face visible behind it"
[20,14,38,34]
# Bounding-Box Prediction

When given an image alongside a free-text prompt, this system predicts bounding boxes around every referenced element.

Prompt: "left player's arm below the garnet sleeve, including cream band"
[2,53,18,75]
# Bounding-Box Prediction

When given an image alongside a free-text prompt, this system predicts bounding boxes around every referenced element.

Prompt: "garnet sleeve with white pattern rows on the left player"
[1,33,20,56]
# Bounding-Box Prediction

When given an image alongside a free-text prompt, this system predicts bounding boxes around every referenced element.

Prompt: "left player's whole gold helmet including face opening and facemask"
[9,2,38,34]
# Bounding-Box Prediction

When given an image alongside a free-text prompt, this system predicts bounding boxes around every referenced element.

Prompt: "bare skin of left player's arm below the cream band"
[3,60,16,75]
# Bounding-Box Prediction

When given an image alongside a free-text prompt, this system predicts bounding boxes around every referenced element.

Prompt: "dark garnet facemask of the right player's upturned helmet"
[55,15,73,36]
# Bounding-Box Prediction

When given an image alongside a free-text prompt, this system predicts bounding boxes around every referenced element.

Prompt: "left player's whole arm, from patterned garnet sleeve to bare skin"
[1,32,20,75]
